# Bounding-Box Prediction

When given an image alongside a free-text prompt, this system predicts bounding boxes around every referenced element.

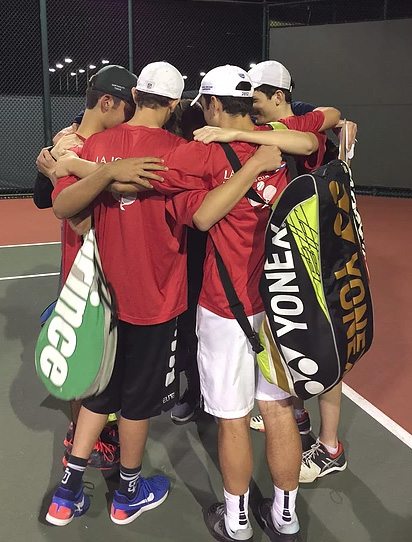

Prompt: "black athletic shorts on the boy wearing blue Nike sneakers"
[83,318,178,420]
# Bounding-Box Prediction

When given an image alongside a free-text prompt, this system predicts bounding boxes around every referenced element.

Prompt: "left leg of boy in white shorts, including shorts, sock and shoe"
[197,307,258,541]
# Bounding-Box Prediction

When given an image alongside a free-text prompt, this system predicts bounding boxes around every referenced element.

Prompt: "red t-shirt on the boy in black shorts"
[55,124,187,325]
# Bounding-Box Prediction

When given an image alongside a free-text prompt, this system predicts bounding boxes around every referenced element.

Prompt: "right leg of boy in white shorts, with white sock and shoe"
[256,371,302,540]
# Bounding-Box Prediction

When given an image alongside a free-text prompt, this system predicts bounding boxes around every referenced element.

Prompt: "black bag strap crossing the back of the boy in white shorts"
[212,143,265,354]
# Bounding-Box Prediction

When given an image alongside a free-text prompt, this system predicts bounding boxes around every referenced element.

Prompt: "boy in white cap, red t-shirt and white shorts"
[146,66,326,541]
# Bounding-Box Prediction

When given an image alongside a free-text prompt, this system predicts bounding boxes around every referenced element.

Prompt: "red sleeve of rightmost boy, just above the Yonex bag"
[279,111,327,173]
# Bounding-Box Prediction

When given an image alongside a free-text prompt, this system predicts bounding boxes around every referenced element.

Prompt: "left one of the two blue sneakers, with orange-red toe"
[46,487,90,527]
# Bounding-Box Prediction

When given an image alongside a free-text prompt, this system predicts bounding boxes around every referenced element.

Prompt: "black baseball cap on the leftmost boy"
[87,64,137,105]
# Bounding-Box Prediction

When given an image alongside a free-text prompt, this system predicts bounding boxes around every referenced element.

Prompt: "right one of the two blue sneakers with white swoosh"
[110,475,170,525]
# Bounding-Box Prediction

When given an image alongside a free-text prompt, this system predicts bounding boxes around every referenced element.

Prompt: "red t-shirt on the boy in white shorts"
[155,138,286,318]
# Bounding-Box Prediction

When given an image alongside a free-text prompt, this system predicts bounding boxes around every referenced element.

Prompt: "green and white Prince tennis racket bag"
[35,229,117,400]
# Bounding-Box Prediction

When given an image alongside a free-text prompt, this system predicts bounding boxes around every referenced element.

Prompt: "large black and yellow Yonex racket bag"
[258,160,373,399]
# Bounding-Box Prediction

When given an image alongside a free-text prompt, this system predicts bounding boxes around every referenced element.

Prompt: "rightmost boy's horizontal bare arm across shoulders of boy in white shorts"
[194,126,318,156]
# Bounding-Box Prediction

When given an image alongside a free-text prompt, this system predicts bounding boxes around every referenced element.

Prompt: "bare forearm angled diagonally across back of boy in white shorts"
[193,146,282,231]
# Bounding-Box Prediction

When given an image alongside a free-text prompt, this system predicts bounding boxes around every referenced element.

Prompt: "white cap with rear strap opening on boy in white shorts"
[190,64,253,105]
